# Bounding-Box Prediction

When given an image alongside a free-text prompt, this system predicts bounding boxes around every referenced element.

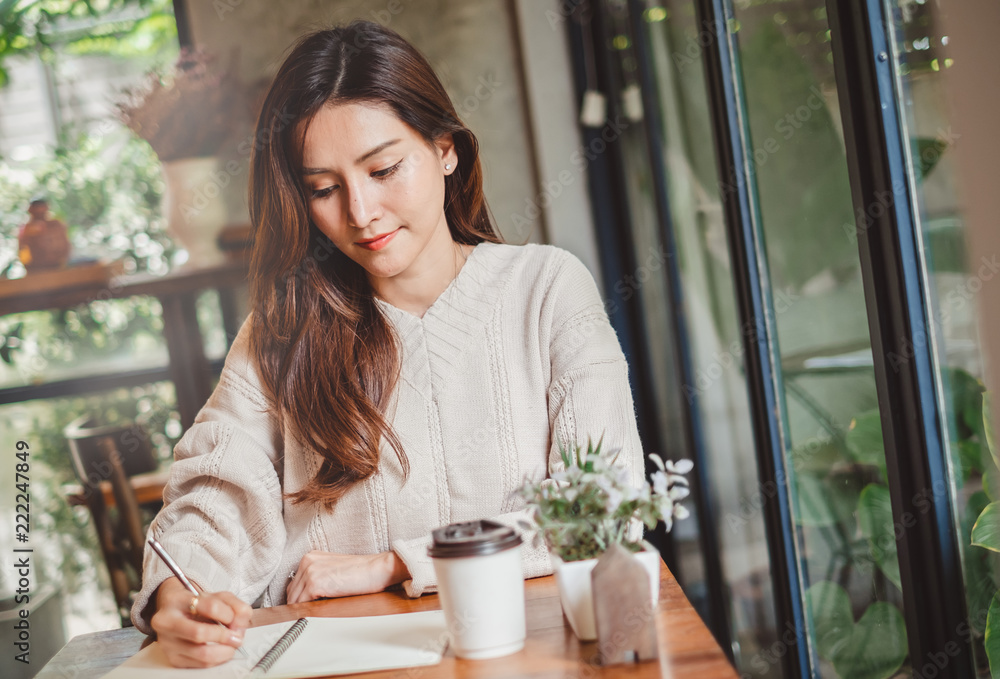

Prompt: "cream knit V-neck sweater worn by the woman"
[132,243,643,633]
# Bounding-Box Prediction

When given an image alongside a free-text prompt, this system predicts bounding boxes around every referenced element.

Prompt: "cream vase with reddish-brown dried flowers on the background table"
[118,48,250,267]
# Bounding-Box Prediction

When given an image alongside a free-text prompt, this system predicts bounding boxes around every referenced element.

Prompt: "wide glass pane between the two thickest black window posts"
[728,0,912,679]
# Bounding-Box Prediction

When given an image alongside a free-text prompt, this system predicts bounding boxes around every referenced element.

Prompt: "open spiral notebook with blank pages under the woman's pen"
[103,611,447,679]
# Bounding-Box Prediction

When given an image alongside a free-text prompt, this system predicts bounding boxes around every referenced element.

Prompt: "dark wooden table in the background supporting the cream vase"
[0,257,249,429]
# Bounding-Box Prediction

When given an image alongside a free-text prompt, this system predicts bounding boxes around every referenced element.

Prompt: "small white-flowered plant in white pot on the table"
[519,442,693,641]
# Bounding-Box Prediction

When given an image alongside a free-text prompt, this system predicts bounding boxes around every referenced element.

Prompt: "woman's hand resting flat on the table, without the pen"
[287,551,410,604]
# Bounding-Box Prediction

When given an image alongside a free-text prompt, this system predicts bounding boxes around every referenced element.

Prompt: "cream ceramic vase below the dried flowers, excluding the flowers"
[162,156,230,268]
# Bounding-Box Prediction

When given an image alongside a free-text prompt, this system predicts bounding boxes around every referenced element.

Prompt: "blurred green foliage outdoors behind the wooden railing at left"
[0,0,186,615]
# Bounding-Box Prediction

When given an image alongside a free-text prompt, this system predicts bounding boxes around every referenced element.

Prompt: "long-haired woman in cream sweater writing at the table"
[132,22,642,666]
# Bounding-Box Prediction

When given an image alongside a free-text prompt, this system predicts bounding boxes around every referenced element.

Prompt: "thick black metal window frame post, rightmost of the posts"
[826,0,974,678]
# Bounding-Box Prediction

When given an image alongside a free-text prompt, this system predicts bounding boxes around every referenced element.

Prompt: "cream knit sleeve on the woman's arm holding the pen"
[132,321,285,634]
